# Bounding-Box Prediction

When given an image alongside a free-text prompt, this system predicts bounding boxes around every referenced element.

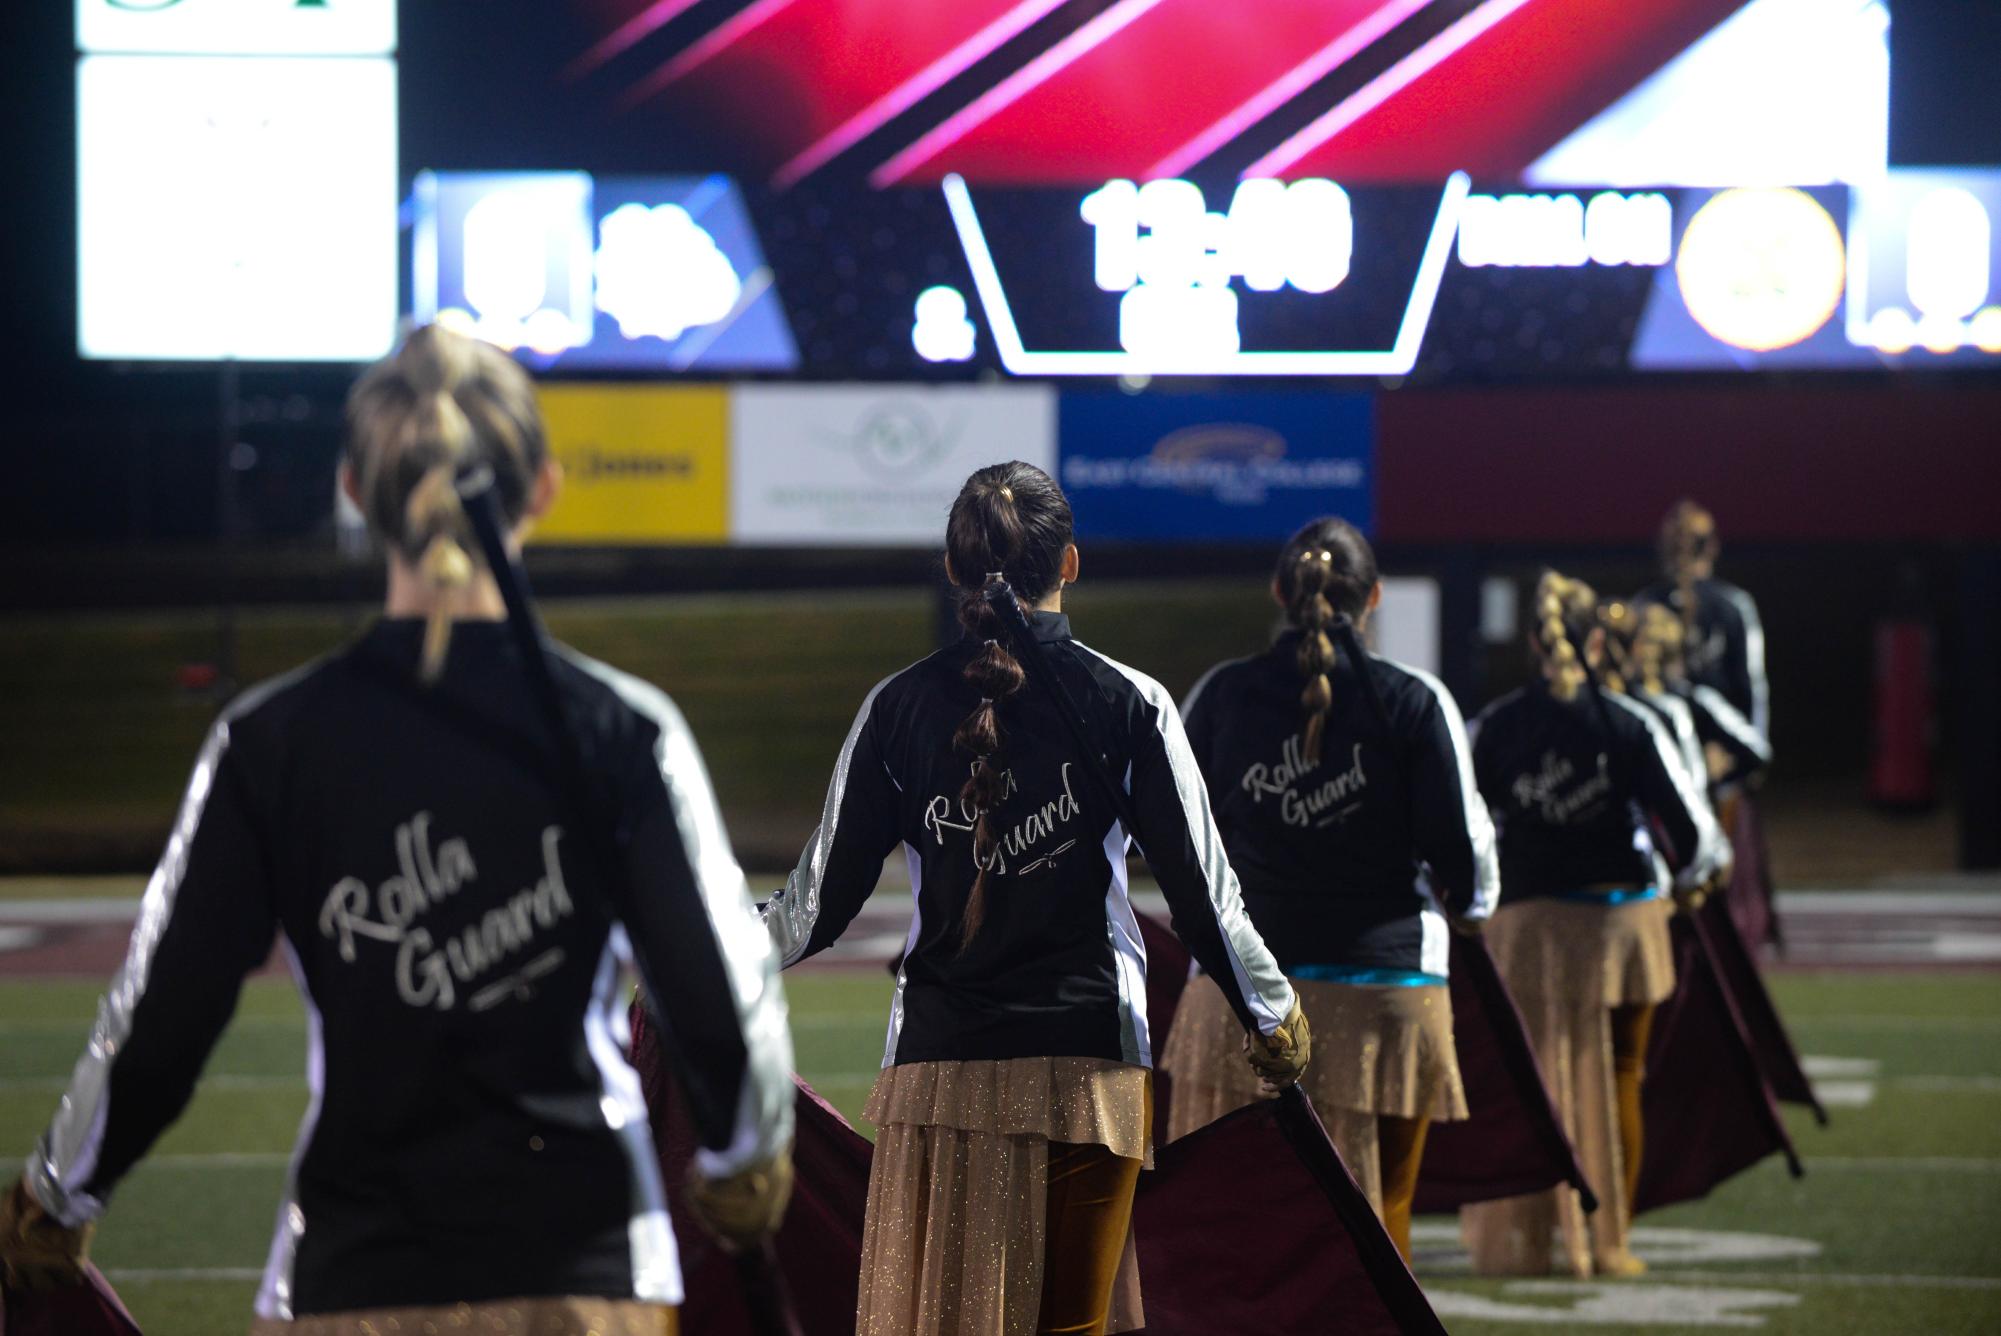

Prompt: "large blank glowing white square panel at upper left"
[76,56,396,362]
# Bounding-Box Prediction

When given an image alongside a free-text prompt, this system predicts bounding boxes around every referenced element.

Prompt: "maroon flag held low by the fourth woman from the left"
[1633,914,1803,1214]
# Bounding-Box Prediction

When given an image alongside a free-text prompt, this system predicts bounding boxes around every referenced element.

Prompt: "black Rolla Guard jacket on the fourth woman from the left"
[1473,682,1725,904]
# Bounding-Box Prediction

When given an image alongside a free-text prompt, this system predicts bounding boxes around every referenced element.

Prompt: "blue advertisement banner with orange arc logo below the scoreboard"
[1057,394,1375,544]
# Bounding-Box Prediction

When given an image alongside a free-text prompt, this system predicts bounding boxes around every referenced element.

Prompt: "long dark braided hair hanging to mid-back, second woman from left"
[944,460,1073,950]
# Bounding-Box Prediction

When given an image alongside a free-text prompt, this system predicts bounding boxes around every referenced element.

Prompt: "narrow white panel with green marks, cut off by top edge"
[76,0,396,56]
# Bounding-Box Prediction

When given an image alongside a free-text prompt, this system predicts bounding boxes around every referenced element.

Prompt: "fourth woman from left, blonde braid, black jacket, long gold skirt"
[1461,572,1723,1276]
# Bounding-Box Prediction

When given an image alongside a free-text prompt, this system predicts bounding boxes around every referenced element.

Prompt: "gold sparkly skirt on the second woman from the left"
[854,1058,1153,1336]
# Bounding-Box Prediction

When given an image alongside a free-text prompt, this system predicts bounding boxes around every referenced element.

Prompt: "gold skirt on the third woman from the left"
[1161,974,1467,1214]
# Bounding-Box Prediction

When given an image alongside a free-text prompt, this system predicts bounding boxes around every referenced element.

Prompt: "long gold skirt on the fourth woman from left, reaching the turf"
[1459,898,1675,1276]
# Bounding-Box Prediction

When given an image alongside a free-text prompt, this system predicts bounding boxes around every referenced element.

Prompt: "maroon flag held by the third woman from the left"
[1413,934,1597,1214]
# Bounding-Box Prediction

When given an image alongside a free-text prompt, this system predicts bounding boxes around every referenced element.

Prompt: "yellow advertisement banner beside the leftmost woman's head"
[534,384,730,546]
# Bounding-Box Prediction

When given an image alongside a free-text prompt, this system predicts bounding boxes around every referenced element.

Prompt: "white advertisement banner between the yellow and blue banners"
[730,386,1057,548]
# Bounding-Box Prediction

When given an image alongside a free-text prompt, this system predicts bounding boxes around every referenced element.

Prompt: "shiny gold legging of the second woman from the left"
[1035,1142,1141,1336]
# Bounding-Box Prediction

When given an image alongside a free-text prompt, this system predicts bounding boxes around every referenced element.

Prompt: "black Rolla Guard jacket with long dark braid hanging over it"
[764,612,1293,1066]
